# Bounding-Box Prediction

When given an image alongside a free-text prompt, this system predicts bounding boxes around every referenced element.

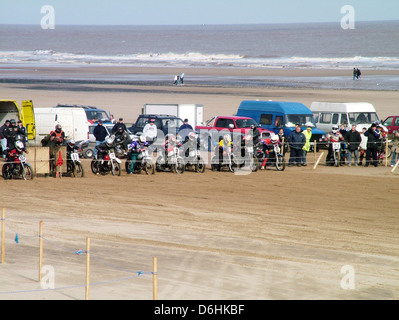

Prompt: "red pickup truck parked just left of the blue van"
[195,116,274,150]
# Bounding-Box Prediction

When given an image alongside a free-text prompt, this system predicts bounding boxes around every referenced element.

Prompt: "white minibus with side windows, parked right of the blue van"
[310,102,380,132]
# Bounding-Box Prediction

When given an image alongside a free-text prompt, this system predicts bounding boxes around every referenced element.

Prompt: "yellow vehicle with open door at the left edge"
[0,99,36,140]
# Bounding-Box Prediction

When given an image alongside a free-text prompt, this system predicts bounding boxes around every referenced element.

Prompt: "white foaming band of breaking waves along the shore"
[0,49,399,69]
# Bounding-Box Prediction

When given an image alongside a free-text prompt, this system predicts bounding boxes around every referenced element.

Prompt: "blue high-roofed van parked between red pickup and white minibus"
[237,100,326,142]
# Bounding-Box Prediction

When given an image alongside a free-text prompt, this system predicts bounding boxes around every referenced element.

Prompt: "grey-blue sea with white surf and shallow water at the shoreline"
[0,21,399,90]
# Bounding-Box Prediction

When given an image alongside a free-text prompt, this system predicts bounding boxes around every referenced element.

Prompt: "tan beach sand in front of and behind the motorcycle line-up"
[0,67,399,300]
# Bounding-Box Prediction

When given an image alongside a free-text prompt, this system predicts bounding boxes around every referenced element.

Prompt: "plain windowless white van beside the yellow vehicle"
[33,107,90,144]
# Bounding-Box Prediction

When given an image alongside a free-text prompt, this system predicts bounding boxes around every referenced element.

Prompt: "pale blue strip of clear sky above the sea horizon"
[0,0,399,25]
